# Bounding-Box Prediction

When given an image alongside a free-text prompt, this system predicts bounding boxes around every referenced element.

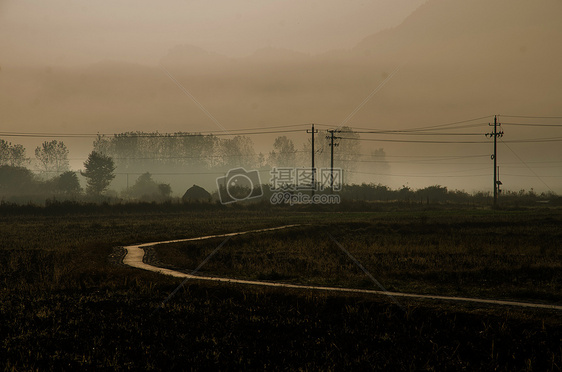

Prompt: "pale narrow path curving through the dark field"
[123,225,562,310]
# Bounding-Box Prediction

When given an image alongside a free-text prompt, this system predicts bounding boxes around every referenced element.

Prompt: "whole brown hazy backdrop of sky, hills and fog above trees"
[0,0,562,195]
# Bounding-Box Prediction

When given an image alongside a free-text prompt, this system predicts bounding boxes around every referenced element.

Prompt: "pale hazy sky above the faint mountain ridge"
[0,0,424,65]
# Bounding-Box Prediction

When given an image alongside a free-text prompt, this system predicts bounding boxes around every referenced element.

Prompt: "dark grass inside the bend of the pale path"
[153,212,562,304]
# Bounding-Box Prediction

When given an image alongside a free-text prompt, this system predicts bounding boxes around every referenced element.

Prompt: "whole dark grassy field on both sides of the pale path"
[0,206,562,371]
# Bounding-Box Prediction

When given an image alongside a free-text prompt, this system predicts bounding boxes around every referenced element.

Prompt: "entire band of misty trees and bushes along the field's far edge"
[6,131,556,204]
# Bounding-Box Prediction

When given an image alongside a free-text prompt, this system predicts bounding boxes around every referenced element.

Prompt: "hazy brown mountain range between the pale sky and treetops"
[0,0,562,155]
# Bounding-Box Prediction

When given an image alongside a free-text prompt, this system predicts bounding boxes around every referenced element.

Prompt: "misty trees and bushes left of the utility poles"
[0,132,334,200]
